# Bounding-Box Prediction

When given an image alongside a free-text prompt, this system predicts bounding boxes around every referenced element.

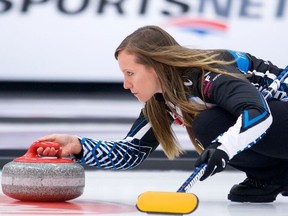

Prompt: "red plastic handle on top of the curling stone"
[14,141,73,163]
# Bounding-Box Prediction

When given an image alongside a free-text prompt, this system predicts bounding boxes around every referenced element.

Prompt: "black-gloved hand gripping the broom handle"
[195,142,229,181]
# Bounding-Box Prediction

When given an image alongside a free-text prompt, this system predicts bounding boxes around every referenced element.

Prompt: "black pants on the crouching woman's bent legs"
[194,100,288,183]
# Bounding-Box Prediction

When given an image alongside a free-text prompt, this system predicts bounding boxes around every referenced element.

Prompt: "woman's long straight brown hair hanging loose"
[114,26,236,159]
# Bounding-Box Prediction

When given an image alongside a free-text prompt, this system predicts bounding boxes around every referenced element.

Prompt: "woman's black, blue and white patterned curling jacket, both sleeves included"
[75,50,288,170]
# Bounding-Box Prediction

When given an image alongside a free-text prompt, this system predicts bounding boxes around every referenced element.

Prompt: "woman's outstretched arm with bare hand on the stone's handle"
[38,112,159,170]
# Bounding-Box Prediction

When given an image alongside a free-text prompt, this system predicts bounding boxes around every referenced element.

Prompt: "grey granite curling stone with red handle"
[2,142,85,202]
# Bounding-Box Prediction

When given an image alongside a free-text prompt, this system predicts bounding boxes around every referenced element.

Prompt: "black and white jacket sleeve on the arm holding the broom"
[203,70,272,159]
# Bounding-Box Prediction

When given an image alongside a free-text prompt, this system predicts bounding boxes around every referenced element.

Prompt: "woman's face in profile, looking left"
[118,50,162,102]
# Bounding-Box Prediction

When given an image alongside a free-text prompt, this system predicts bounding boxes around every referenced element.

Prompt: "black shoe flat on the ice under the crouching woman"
[228,178,288,203]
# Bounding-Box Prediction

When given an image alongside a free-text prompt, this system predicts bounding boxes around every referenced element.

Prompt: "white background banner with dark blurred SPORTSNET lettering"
[0,0,288,82]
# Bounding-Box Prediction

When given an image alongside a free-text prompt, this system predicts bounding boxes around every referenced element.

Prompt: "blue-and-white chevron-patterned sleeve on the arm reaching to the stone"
[76,112,159,170]
